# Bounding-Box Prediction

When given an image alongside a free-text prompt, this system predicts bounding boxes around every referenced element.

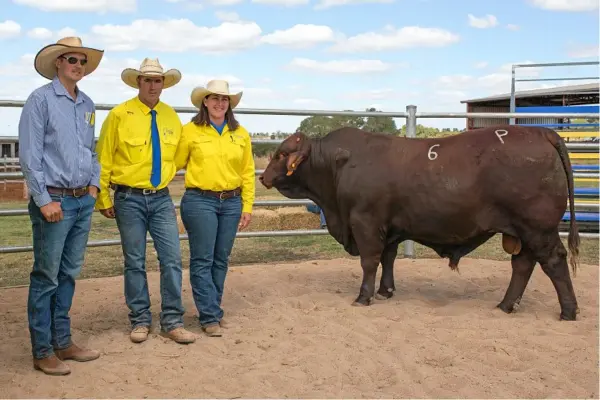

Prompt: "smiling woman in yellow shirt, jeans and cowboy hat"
[175,80,255,336]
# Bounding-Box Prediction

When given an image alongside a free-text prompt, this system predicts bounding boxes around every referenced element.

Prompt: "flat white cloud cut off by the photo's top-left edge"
[13,0,137,13]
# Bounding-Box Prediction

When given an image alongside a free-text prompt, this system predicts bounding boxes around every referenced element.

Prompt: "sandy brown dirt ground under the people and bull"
[0,259,599,398]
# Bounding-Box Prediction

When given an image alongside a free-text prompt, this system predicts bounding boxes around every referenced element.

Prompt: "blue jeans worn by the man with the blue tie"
[114,190,185,332]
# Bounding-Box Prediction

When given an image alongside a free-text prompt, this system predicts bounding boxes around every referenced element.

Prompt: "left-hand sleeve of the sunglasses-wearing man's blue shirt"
[19,92,52,207]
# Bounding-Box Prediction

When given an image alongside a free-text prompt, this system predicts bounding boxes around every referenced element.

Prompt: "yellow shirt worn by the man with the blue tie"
[96,96,182,210]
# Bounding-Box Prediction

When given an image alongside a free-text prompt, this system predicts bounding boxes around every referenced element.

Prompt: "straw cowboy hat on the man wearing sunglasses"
[33,36,104,80]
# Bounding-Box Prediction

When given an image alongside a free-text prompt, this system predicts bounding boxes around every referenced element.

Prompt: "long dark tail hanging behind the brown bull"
[546,129,580,276]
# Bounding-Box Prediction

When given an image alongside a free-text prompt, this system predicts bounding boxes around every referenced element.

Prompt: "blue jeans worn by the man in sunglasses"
[27,194,96,359]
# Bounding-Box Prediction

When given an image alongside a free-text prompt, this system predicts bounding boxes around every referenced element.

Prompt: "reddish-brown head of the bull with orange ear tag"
[258,132,310,189]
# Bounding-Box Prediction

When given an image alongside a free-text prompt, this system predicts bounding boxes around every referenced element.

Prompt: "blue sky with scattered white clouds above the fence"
[0,0,600,136]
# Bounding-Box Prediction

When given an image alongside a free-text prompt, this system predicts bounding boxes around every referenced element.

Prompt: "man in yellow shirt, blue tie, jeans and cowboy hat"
[96,58,195,343]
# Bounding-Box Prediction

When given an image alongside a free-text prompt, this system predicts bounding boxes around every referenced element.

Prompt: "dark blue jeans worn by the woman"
[180,189,242,327]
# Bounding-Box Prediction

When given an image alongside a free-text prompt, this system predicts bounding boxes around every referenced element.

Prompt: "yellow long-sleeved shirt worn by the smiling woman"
[175,122,256,213]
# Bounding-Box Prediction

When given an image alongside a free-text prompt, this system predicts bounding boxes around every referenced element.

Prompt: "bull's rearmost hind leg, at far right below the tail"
[535,232,579,321]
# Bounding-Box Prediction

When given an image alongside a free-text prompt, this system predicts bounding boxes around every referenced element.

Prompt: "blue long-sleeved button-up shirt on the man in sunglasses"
[19,78,100,207]
